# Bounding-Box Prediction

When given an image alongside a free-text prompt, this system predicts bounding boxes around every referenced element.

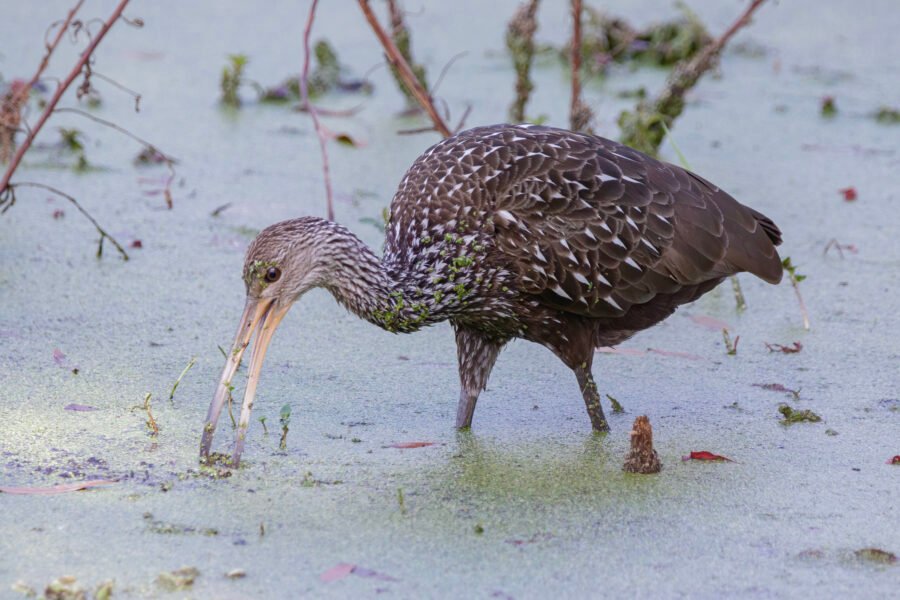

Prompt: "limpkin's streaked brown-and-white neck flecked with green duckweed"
[324,231,461,333]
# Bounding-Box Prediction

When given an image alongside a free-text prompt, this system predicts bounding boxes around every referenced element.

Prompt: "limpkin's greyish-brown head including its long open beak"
[200,217,342,465]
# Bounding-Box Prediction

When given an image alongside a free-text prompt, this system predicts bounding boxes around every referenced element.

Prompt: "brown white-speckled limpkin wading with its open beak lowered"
[200,125,782,464]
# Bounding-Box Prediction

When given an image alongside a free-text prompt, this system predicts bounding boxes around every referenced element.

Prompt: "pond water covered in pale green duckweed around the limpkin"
[0,0,900,598]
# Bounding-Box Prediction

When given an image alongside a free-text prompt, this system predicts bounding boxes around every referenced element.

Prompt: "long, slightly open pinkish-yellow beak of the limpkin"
[200,297,291,467]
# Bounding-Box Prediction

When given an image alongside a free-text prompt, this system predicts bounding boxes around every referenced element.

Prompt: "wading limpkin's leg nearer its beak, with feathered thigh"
[454,324,506,429]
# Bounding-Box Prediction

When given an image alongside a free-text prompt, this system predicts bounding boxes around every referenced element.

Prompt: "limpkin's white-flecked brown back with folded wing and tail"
[385,125,782,330]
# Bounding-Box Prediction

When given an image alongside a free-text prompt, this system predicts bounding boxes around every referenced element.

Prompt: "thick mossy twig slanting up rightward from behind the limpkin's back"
[619,0,766,154]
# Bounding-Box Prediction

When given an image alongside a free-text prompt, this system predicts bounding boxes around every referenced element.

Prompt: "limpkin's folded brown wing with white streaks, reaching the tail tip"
[493,127,782,317]
